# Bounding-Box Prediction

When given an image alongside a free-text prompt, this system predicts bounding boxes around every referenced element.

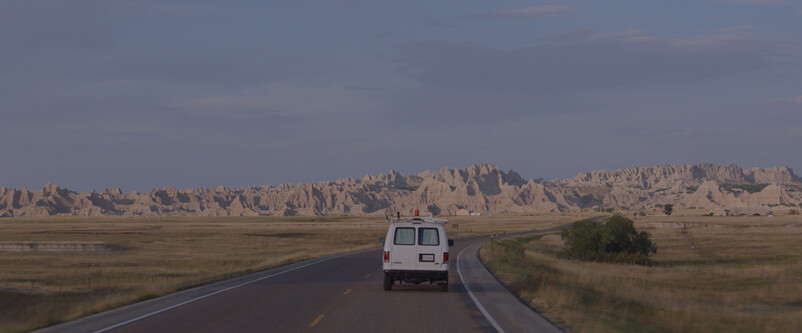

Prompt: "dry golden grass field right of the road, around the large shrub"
[481,216,802,332]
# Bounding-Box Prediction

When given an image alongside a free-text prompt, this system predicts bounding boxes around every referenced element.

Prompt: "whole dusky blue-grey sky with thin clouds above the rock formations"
[0,0,802,192]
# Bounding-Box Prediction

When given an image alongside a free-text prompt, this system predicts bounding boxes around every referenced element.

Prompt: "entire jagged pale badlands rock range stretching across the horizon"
[0,164,802,216]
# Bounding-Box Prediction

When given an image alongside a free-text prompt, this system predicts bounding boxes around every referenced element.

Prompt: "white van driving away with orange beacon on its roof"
[379,217,454,291]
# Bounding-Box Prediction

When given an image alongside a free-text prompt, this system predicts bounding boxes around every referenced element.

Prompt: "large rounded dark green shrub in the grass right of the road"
[562,215,657,264]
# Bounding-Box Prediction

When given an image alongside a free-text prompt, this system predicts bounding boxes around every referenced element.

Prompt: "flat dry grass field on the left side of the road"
[0,215,576,332]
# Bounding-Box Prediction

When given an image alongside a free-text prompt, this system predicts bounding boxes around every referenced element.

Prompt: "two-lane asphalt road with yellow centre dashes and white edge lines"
[41,231,561,332]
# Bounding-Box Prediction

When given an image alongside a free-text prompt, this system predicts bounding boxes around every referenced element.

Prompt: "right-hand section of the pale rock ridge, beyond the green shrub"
[564,164,802,209]
